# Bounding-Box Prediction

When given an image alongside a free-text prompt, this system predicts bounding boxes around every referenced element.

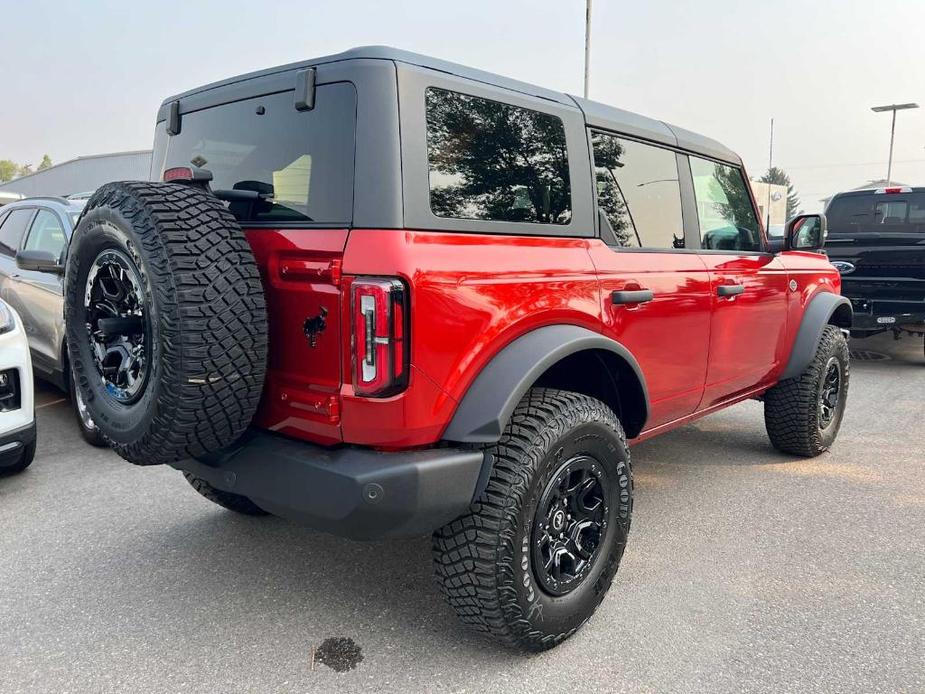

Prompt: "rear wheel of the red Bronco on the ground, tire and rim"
[433,388,633,651]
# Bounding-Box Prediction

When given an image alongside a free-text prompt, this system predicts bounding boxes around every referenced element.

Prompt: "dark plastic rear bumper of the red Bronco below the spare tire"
[173,430,490,539]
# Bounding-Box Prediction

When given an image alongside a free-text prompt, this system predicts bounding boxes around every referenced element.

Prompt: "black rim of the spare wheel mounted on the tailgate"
[84,249,151,405]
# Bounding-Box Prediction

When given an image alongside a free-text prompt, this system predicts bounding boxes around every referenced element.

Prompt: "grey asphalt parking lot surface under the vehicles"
[0,337,925,692]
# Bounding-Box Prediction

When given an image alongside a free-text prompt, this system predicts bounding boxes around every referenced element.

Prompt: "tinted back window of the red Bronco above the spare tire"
[155,82,356,225]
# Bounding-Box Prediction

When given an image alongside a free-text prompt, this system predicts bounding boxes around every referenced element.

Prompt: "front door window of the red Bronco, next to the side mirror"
[690,157,763,253]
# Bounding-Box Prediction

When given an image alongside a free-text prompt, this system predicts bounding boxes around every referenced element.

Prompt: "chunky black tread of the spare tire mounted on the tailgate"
[66,181,267,465]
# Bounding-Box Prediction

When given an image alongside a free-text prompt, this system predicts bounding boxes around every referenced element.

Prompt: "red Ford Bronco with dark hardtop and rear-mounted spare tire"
[65,47,852,650]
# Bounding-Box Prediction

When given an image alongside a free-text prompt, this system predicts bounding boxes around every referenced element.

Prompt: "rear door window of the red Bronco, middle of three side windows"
[591,132,684,248]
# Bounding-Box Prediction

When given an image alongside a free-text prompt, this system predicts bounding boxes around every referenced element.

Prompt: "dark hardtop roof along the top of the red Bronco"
[161,46,742,165]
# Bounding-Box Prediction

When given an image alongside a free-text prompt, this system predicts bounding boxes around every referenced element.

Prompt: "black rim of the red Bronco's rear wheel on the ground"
[532,455,608,596]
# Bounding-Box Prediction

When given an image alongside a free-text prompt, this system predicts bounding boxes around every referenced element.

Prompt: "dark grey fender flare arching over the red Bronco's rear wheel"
[443,325,649,443]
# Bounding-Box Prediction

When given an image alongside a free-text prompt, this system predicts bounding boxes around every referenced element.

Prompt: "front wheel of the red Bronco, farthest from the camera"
[764,325,850,458]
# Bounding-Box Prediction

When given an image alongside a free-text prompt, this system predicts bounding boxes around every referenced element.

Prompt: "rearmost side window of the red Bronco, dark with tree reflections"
[426,88,572,224]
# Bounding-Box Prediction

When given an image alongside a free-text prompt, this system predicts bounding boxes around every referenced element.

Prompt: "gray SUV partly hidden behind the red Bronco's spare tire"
[0,197,105,446]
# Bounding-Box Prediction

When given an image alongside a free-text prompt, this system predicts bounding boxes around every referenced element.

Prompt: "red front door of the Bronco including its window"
[685,155,790,409]
